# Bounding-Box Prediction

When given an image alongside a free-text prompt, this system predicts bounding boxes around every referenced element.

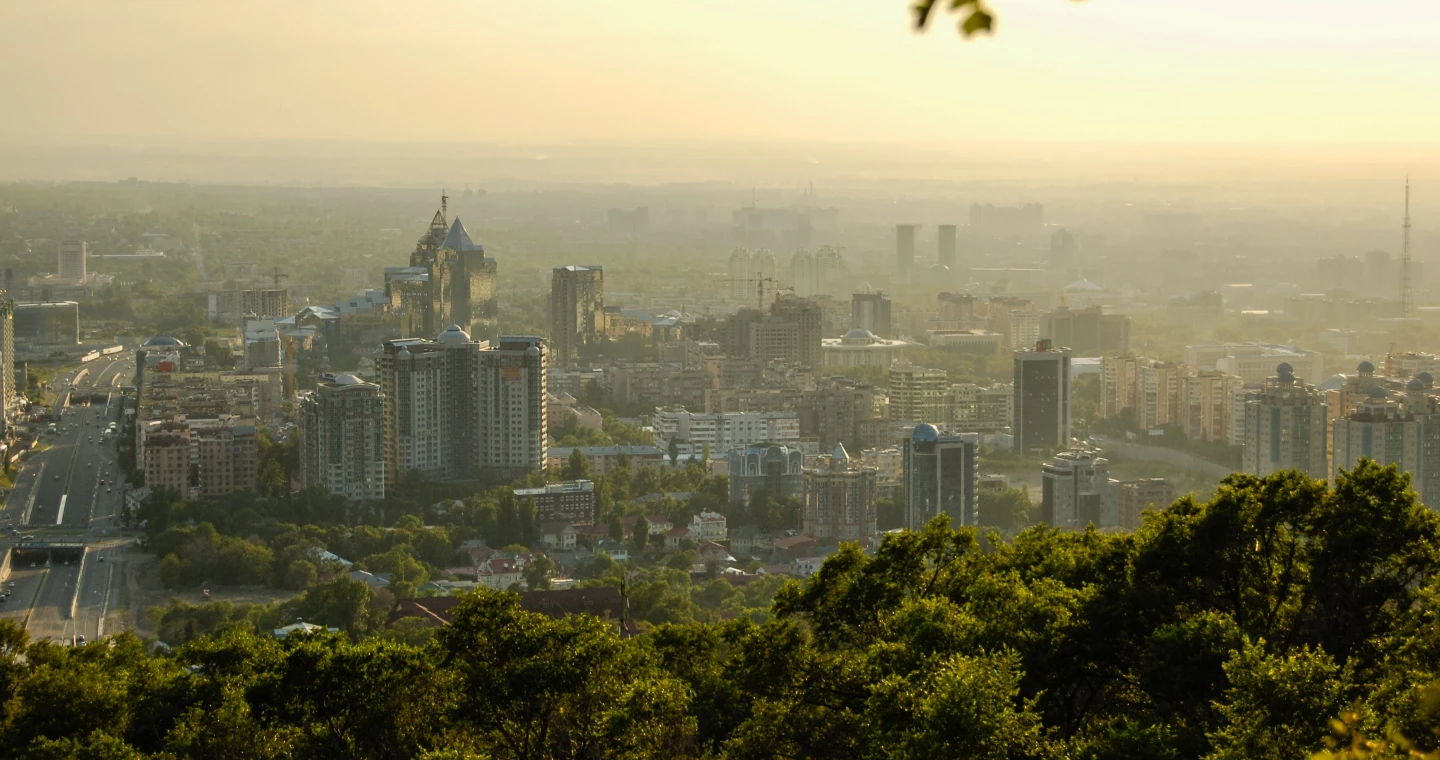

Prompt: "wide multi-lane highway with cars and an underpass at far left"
[0,357,134,641]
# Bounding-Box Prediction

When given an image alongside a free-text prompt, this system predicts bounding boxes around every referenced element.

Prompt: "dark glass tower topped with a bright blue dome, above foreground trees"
[900,423,979,530]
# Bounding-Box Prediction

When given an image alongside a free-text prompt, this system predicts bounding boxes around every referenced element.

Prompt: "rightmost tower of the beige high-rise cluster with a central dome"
[475,335,549,479]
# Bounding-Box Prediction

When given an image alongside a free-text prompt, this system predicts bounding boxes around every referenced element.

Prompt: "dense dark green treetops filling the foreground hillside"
[14,462,1440,760]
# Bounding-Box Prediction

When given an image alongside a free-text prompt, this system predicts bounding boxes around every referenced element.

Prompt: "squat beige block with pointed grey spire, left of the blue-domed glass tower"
[801,446,880,543]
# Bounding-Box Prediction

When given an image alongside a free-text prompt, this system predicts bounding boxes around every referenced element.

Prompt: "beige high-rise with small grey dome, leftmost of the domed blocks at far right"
[1243,363,1331,478]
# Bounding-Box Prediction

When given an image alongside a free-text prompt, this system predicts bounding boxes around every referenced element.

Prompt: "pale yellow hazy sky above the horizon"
[0,0,1440,144]
